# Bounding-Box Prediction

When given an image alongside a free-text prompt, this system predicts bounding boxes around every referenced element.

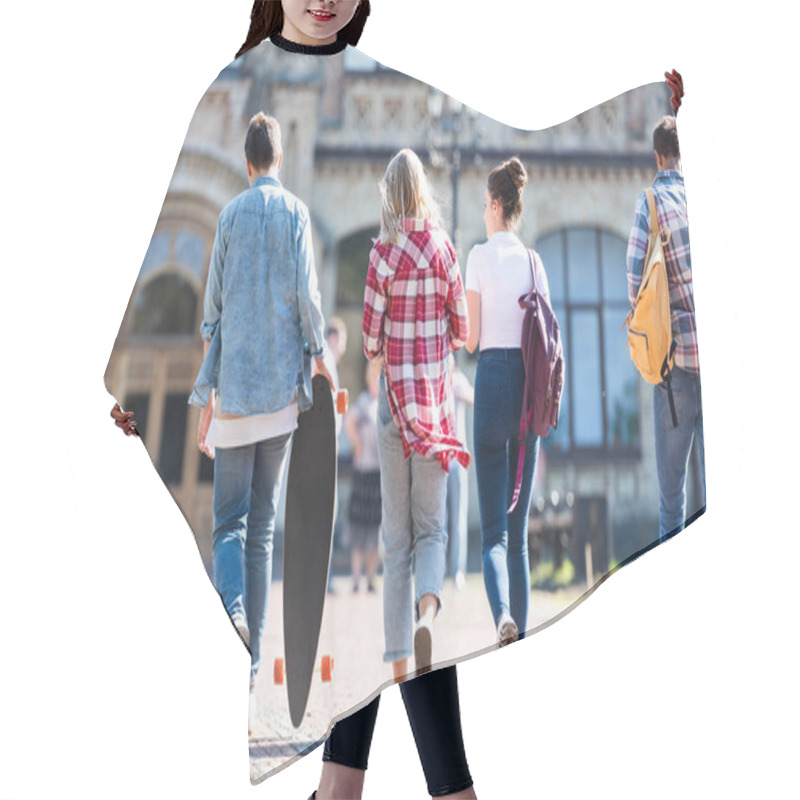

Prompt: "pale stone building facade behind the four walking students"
[106,43,702,567]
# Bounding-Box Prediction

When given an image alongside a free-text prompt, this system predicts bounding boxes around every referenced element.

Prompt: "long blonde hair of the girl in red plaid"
[379,147,441,244]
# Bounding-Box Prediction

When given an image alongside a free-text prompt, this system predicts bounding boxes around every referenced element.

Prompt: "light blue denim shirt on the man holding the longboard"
[189,176,324,416]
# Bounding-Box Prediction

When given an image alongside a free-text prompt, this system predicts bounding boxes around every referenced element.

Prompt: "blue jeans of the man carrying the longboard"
[212,433,292,675]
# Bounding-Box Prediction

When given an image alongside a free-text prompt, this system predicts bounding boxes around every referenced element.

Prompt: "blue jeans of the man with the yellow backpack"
[653,367,706,542]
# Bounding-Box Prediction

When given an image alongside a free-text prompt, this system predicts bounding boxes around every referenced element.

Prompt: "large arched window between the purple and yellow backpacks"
[536,228,639,456]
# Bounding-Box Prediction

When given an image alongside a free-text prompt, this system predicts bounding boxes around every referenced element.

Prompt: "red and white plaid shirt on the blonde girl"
[363,219,470,471]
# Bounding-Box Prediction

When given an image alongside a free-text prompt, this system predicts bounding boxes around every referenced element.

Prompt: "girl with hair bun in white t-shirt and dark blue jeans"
[466,158,549,646]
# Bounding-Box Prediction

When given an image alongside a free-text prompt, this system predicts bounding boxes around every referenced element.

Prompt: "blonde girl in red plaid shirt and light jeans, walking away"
[363,149,470,680]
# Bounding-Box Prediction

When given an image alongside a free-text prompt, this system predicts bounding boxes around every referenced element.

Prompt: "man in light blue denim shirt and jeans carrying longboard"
[189,113,333,686]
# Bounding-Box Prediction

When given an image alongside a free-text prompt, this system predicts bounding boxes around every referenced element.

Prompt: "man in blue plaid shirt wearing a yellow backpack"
[626,116,705,541]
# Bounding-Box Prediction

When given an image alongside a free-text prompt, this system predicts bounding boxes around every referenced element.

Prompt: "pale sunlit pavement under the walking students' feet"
[249,574,586,783]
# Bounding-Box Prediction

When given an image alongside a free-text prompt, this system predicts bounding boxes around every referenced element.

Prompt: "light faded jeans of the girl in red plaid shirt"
[378,376,447,661]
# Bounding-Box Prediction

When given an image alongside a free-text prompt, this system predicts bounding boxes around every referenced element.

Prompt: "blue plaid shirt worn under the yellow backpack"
[627,170,700,375]
